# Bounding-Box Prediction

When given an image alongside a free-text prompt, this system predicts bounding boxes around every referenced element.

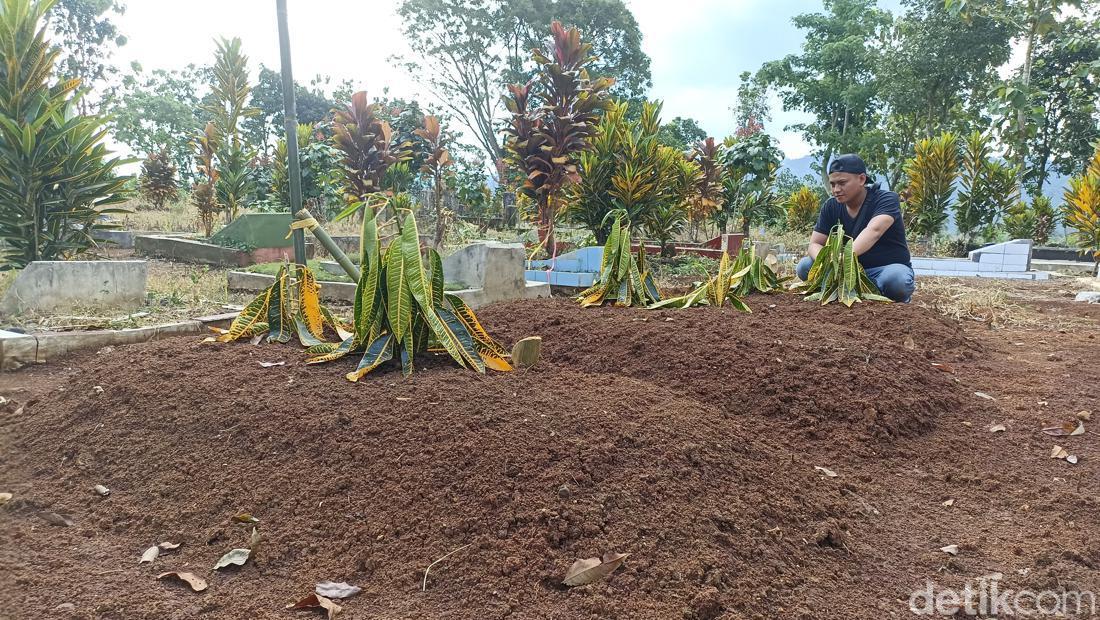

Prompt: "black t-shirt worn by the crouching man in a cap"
[814,187,910,269]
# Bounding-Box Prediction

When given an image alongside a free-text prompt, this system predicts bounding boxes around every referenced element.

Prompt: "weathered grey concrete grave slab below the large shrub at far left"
[0,261,147,315]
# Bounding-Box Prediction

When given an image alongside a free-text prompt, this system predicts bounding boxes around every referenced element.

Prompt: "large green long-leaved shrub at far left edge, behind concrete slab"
[0,0,128,268]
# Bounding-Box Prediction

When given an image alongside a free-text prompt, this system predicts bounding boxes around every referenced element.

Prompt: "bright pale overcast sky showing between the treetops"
[109,0,899,158]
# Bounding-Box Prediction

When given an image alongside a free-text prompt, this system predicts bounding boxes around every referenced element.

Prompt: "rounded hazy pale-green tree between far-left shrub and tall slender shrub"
[103,65,210,185]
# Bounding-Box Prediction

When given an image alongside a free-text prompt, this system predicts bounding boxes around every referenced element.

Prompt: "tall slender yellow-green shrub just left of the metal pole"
[206,37,259,222]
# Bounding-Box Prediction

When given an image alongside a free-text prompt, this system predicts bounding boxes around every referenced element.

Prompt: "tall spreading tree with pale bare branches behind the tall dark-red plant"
[393,0,650,171]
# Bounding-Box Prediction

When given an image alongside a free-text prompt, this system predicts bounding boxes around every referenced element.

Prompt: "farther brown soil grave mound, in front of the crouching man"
[480,295,980,439]
